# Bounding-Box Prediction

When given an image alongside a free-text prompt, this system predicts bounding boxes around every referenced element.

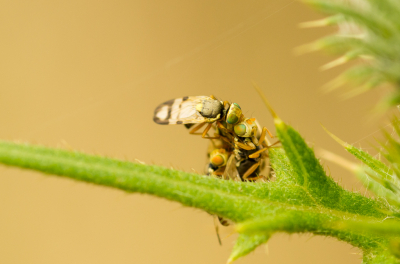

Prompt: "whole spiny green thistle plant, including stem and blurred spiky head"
[0,0,400,264]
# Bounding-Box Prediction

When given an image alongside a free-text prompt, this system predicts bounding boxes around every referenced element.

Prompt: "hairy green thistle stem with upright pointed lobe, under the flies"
[0,111,400,263]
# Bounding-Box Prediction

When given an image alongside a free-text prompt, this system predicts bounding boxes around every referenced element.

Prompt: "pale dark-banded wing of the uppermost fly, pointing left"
[153,96,211,125]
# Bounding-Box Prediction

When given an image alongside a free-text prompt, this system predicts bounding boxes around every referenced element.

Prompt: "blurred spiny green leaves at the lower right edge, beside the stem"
[324,114,400,263]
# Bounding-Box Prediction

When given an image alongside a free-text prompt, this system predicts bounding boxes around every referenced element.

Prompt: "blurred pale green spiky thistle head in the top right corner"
[303,0,400,107]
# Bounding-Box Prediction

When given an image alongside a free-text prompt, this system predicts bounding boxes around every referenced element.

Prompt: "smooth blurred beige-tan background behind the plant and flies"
[0,0,386,264]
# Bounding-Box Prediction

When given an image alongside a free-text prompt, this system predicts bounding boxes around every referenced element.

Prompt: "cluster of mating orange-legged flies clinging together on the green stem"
[153,96,272,181]
